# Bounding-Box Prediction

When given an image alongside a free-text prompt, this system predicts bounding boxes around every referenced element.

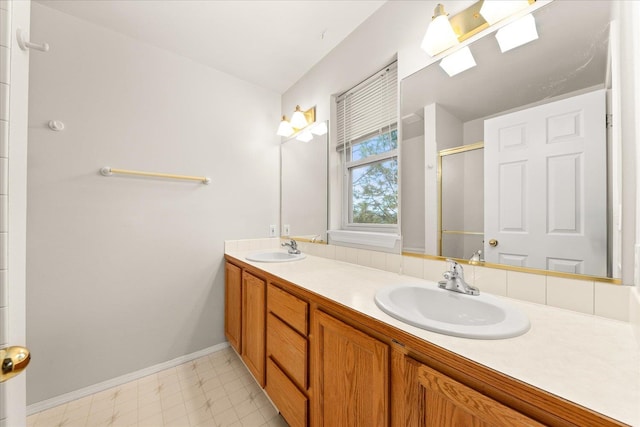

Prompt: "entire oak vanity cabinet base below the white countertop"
[225,258,624,427]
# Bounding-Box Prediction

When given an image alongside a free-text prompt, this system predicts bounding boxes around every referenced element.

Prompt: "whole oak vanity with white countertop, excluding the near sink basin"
[225,251,640,427]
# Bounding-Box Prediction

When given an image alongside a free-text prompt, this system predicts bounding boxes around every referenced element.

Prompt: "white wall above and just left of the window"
[282,0,474,234]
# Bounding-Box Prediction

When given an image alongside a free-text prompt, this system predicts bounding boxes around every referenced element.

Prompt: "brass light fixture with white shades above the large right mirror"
[420,0,536,56]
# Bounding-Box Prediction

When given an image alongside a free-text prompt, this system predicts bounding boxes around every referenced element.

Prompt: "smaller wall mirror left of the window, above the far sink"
[280,122,329,243]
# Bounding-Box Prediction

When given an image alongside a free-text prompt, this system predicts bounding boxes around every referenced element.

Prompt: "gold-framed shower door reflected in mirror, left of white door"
[438,142,484,259]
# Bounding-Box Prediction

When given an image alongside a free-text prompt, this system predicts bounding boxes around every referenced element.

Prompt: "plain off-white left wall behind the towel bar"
[27,3,281,404]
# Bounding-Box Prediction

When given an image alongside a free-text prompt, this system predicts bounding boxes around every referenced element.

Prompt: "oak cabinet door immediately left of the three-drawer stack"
[241,271,267,387]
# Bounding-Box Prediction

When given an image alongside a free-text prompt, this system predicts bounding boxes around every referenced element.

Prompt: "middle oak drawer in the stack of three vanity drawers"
[267,313,308,390]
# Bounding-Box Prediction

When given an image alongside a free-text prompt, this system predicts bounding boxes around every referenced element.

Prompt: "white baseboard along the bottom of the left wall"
[27,342,229,416]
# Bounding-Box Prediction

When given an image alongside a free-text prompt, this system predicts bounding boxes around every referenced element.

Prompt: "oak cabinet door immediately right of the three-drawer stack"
[311,311,389,427]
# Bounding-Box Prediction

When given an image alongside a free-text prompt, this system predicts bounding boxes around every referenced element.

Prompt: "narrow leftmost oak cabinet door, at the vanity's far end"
[224,262,242,353]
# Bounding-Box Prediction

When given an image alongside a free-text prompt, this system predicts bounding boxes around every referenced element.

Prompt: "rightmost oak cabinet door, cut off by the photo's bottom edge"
[411,365,542,427]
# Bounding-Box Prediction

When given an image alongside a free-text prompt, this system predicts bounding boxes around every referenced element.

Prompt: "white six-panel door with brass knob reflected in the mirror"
[484,90,607,276]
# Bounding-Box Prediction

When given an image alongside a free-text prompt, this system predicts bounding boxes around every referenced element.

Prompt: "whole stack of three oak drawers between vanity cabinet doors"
[265,283,309,427]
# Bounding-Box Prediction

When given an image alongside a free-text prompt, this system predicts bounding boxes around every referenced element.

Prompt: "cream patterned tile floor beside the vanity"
[27,347,287,427]
